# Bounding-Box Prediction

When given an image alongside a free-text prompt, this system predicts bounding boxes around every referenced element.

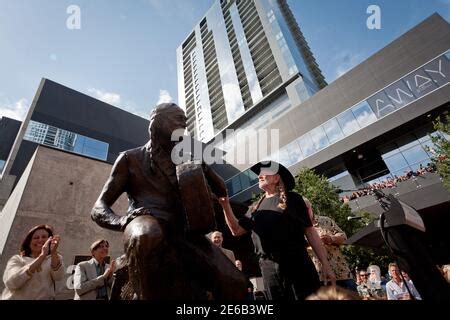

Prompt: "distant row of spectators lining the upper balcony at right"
[341,163,436,203]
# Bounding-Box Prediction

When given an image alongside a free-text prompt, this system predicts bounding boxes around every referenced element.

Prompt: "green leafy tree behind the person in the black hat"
[294,168,392,270]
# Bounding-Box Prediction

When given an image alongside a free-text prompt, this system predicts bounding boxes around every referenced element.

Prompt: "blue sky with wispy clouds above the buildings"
[0,0,450,120]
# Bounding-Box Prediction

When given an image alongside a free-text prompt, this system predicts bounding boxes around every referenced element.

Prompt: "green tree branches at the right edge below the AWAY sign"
[429,114,450,190]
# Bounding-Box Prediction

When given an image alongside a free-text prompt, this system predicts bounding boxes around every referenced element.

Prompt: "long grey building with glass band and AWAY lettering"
[226,14,450,205]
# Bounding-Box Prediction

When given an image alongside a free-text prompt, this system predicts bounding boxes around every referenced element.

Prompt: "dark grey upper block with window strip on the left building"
[0,79,149,208]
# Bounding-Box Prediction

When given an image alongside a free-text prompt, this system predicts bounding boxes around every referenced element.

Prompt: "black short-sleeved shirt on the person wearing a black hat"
[239,192,312,256]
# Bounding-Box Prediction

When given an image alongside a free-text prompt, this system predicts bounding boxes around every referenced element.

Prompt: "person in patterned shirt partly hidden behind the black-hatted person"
[304,199,357,292]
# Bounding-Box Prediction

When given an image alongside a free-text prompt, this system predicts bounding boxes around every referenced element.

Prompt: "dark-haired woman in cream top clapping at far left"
[2,224,64,300]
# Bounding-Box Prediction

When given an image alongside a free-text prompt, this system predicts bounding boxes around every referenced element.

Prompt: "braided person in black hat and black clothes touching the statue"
[219,161,336,300]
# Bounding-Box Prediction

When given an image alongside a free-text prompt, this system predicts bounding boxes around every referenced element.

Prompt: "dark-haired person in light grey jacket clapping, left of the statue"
[73,239,115,300]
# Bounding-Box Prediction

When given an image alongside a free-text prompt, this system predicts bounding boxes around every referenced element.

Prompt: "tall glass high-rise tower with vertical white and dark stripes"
[177,0,326,142]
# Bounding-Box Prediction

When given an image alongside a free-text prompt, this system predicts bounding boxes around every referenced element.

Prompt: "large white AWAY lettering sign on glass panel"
[367,54,450,119]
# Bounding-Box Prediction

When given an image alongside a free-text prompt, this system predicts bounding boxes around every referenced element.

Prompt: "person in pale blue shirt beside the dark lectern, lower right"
[386,263,422,300]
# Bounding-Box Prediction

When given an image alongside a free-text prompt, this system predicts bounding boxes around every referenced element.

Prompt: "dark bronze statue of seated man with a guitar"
[91,103,246,300]
